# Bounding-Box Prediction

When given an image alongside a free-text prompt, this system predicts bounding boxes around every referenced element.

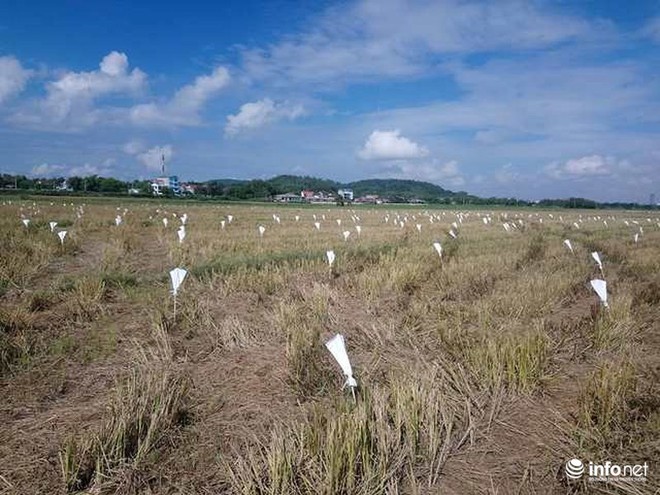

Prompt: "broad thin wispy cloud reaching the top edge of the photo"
[242,0,596,86]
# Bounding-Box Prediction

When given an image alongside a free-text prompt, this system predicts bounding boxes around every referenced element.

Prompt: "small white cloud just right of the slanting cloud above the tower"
[225,98,305,136]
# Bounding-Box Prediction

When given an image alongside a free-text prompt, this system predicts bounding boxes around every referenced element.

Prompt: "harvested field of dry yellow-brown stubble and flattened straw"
[0,199,660,494]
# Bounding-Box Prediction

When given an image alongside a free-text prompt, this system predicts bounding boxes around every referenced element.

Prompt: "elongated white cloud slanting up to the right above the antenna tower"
[130,67,231,127]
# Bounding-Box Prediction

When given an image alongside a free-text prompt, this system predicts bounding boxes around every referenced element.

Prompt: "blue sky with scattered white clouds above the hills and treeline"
[0,0,660,202]
